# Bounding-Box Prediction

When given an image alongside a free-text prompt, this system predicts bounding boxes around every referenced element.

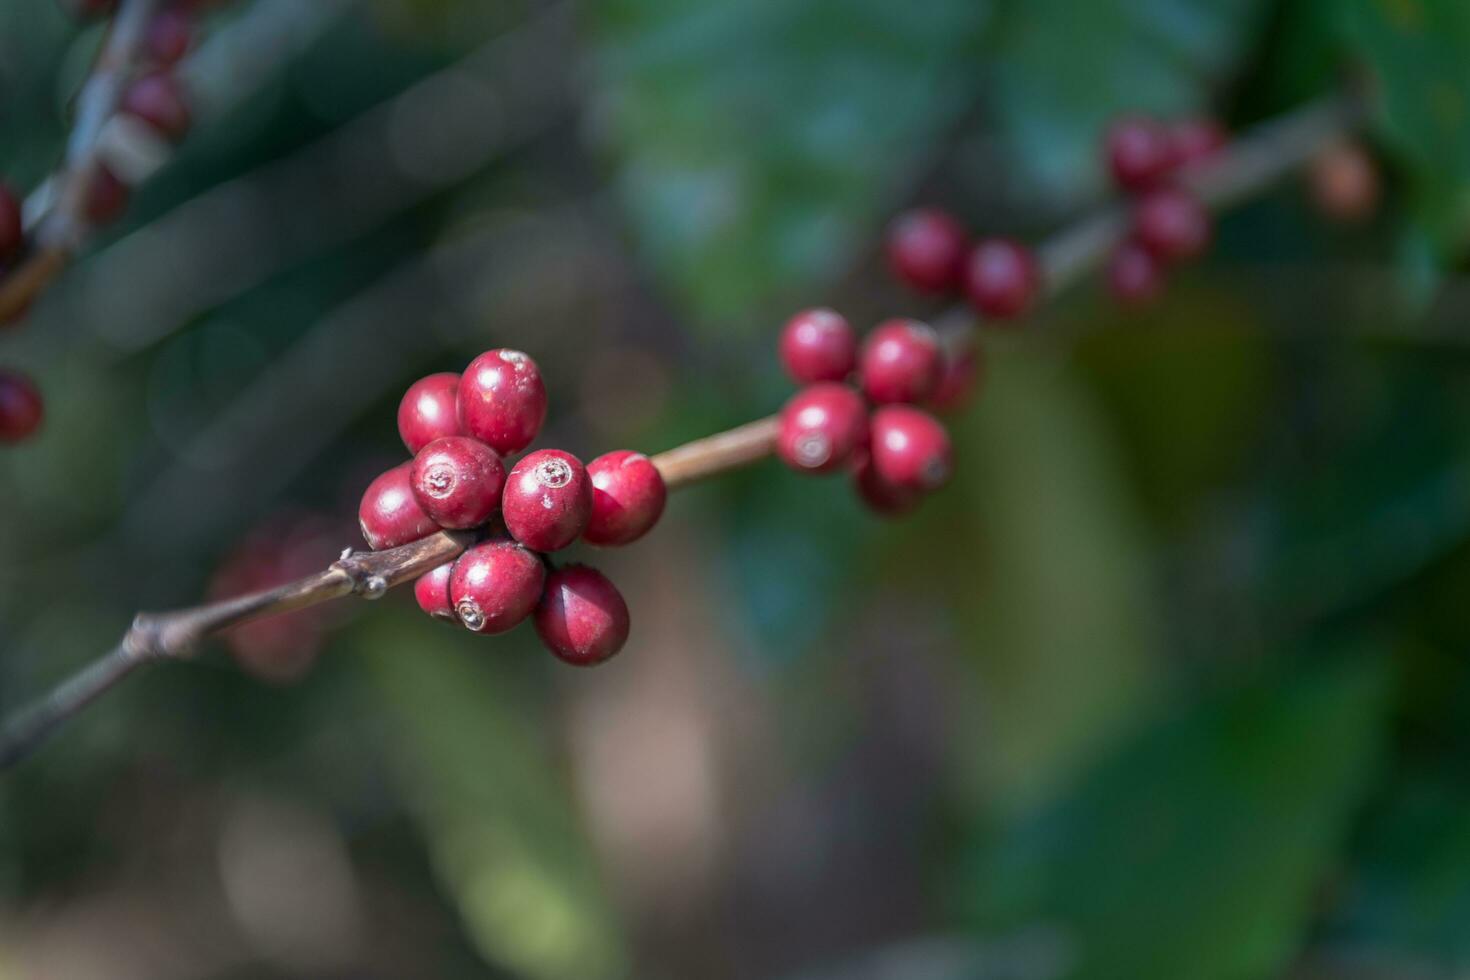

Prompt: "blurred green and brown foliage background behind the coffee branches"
[0,0,1470,980]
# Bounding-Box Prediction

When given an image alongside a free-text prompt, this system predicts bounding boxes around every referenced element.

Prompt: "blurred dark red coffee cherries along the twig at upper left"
[0,0,201,444]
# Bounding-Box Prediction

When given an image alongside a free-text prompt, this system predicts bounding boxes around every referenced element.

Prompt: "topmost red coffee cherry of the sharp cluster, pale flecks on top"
[459,348,547,455]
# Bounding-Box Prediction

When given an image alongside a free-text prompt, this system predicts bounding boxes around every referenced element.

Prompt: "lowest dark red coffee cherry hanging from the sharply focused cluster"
[535,564,629,667]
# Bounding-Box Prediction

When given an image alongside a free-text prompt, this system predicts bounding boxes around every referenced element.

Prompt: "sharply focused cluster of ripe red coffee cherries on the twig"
[357,350,666,666]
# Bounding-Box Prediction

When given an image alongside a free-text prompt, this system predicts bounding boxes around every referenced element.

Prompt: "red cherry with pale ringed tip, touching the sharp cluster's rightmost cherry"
[500,450,592,551]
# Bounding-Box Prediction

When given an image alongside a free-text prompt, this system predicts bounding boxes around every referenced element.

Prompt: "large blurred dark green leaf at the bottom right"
[970,649,1391,980]
